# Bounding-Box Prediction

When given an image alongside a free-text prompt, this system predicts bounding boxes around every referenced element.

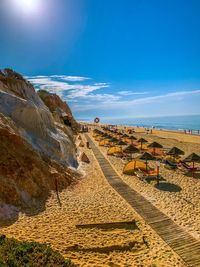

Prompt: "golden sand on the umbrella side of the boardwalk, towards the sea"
[90,126,200,240]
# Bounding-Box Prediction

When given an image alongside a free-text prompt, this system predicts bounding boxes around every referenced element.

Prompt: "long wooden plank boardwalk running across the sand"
[86,134,200,267]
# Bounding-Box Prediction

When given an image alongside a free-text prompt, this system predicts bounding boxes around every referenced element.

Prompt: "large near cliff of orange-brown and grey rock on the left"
[0,69,78,222]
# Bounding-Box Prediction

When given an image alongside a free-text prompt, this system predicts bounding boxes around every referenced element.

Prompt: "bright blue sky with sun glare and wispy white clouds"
[0,0,200,119]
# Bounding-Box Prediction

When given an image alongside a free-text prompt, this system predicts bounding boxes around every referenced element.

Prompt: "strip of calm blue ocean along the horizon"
[79,115,200,133]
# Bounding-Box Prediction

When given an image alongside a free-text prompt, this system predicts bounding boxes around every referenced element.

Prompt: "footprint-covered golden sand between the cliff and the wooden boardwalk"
[0,134,188,267]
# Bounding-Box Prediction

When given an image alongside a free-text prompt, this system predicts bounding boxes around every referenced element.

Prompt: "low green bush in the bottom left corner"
[0,235,76,267]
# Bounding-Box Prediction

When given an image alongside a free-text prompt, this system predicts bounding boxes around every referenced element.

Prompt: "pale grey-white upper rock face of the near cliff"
[0,70,78,167]
